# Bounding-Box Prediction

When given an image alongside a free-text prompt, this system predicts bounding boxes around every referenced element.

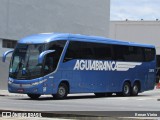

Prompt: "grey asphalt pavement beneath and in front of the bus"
[0,89,160,119]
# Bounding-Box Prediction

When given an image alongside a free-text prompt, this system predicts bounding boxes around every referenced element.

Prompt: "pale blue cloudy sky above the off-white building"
[110,0,160,20]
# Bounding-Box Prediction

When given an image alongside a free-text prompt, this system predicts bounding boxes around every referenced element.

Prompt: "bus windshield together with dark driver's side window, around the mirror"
[9,40,66,80]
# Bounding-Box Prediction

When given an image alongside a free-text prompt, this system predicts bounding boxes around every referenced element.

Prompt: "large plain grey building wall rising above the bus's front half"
[0,0,110,40]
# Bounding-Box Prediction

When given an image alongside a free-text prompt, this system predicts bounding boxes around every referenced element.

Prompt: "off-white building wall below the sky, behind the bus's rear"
[109,21,160,55]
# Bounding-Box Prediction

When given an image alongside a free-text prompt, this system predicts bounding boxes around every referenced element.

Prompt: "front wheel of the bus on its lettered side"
[53,83,68,99]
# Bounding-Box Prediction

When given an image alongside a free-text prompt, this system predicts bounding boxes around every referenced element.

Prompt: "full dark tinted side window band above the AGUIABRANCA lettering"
[64,41,155,62]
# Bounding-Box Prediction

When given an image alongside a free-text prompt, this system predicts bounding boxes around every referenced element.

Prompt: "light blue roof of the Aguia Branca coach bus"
[18,33,155,48]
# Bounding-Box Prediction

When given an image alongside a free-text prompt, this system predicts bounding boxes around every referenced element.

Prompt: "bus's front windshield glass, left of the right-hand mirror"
[9,44,44,79]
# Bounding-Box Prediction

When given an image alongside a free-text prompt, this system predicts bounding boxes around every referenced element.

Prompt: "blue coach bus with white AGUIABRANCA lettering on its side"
[3,33,156,99]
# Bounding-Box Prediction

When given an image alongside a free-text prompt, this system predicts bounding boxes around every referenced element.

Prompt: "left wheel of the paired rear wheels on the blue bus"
[122,82,131,96]
